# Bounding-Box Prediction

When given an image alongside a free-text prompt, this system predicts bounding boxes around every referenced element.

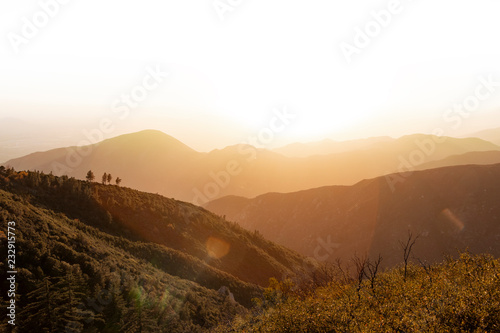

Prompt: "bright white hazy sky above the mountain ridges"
[0,0,500,150]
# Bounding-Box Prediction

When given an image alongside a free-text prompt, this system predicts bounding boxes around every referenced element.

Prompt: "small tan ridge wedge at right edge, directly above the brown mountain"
[415,150,500,170]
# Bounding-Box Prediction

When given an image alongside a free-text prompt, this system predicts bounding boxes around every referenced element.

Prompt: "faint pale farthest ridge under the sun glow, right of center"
[273,136,394,157]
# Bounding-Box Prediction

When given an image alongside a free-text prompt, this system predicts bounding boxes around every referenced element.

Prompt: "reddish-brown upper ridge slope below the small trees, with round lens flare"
[0,167,312,290]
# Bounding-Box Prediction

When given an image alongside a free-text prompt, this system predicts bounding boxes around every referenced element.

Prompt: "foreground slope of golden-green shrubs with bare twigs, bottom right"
[216,253,500,333]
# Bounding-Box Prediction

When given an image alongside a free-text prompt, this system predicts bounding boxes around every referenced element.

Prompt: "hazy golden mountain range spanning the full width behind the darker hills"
[4,131,500,204]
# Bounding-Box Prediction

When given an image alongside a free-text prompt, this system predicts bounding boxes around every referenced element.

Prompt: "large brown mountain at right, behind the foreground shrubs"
[206,164,500,266]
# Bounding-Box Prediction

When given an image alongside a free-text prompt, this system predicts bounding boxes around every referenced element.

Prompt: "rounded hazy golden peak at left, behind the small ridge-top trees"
[5,130,203,197]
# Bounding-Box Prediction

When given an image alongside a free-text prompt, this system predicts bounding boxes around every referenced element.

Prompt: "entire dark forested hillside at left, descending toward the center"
[0,167,314,332]
